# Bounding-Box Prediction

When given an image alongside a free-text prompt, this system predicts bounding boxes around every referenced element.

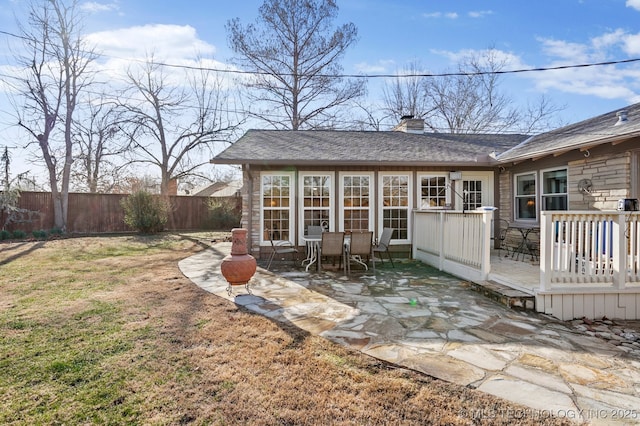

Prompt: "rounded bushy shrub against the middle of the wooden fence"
[121,191,169,234]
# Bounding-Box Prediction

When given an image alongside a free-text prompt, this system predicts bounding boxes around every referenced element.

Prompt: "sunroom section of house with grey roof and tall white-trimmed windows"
[211,120,527,255]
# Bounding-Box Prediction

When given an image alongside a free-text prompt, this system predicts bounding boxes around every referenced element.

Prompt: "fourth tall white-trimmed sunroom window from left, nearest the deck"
[380,173,411,241]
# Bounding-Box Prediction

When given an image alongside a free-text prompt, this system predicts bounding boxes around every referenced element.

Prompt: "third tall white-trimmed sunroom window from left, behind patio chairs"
[340,173,373,232]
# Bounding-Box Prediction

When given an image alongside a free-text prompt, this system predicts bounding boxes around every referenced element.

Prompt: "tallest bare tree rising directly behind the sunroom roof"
[226,0,365,130]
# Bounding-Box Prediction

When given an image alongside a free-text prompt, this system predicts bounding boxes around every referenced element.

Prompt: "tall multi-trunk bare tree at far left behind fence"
[16,0,96,231]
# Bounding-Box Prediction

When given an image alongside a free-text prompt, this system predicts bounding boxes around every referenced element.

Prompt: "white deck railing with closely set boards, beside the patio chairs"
[413,210,493,281]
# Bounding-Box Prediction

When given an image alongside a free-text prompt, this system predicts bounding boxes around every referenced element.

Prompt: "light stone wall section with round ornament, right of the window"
[567,152,631,210]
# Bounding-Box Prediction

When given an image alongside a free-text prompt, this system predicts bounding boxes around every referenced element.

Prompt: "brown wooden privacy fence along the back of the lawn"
[0,192,242,234]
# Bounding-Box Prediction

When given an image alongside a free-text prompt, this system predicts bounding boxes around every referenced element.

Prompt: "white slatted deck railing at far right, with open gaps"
[540,211,640,291]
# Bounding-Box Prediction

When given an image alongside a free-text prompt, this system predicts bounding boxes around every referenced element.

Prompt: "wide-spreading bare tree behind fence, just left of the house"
[121,58,241,195]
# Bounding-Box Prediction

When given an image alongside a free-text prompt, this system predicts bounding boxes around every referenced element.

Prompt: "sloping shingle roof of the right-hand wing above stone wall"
[498,103,640,163]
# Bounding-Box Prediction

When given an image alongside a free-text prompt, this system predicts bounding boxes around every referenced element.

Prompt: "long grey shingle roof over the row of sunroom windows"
[211,130,528,166]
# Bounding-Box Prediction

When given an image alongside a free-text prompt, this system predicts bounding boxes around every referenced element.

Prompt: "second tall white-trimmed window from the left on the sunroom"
[300,172,333,235]
